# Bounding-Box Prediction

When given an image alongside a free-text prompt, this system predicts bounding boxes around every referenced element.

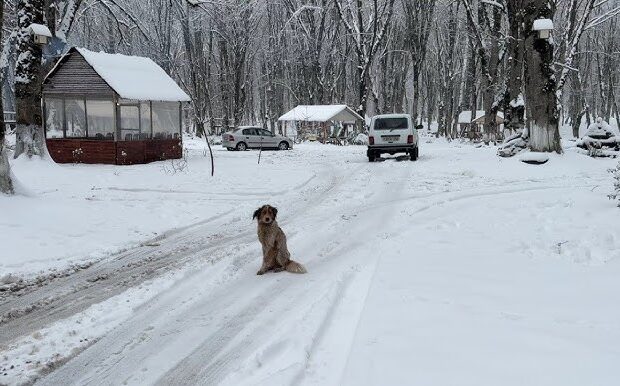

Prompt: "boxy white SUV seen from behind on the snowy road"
[366,114,419,162]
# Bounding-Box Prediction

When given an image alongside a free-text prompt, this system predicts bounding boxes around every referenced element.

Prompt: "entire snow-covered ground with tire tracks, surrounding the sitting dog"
[0,139,620,385]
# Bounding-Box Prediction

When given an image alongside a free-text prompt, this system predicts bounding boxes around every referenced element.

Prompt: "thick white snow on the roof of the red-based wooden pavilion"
[77,48,191,102]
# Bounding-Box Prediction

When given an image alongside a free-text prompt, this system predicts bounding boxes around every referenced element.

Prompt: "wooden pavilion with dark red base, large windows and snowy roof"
[43,48,190,165]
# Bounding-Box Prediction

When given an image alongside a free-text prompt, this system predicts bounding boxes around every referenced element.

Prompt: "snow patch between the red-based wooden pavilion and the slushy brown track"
[0,141,314,278]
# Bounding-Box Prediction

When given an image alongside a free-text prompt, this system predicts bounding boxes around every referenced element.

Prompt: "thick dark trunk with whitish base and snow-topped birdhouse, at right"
[524,0,562,153]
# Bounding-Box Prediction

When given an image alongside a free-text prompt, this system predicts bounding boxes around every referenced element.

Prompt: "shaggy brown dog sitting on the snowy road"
[252,205,306,275]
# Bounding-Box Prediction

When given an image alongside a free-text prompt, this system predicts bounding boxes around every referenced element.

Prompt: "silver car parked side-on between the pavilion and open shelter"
[222,126,293,151]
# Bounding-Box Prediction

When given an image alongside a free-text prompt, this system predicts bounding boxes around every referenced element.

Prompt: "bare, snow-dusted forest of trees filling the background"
[0,0,620,182]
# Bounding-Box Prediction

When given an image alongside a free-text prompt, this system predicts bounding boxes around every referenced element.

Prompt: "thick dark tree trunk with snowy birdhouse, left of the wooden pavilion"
[15,0,46,158]
